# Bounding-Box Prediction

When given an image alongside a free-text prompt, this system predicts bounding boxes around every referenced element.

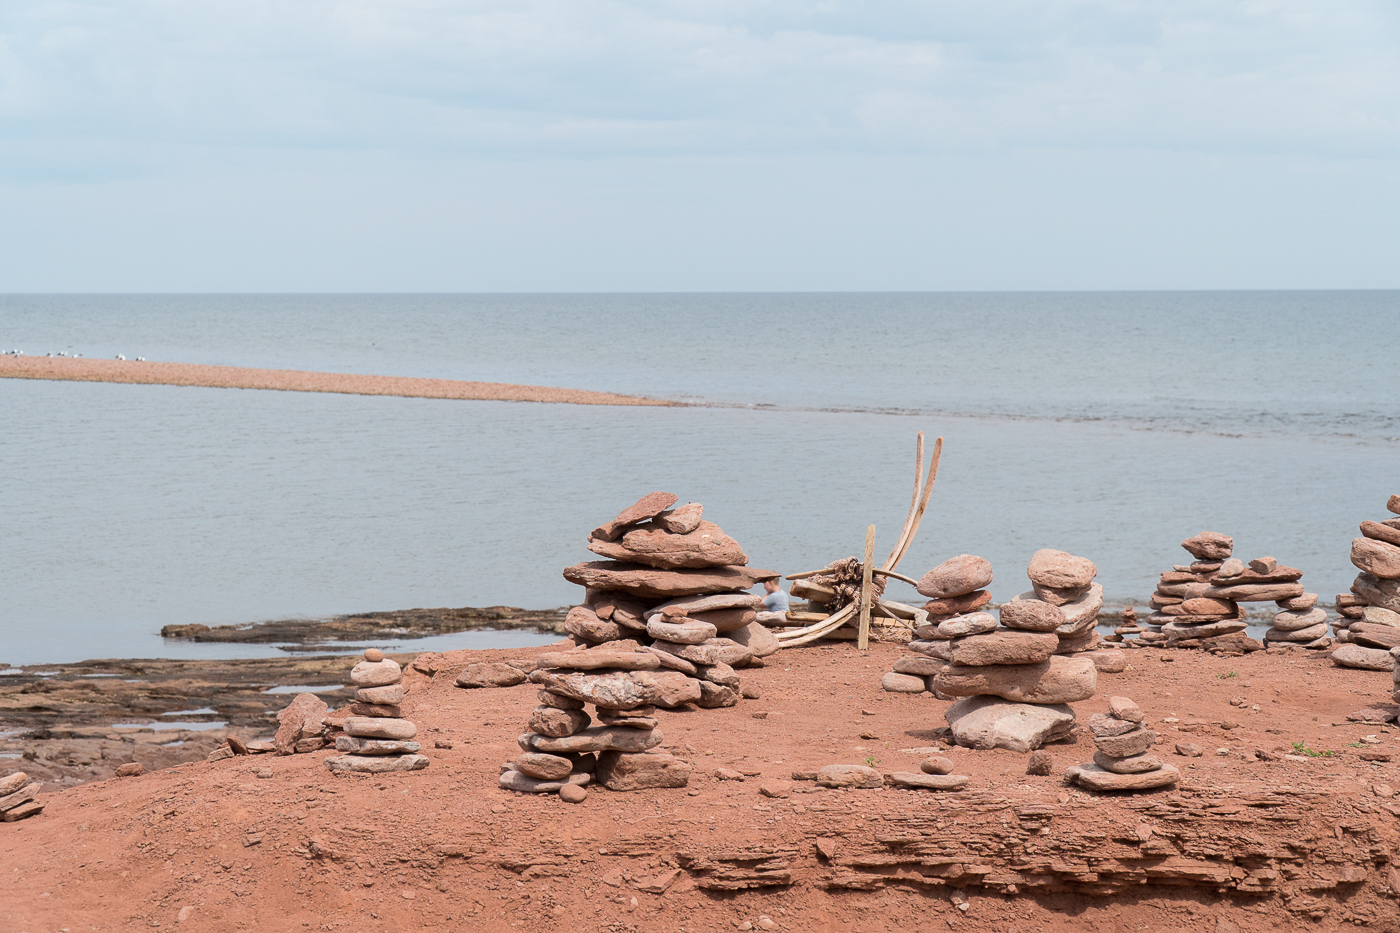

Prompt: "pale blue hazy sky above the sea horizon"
[0,0,1400,293]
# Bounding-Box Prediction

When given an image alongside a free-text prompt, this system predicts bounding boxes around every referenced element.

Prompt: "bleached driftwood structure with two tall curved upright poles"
[777,431,944,649]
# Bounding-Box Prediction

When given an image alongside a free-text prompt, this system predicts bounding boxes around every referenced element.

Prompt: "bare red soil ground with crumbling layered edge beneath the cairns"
[0,644,1400,933]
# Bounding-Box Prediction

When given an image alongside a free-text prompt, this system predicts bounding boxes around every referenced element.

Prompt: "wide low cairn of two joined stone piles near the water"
[1138,531,1331,650]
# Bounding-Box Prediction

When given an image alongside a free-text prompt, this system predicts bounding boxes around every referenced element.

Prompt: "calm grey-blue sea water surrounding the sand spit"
[0,293,1400,664]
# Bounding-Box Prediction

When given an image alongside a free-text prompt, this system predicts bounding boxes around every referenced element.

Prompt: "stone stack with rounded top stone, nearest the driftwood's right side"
[881,553,997,693]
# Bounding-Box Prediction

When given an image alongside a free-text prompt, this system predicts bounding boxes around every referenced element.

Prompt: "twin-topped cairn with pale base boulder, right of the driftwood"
[885,551,1102,751]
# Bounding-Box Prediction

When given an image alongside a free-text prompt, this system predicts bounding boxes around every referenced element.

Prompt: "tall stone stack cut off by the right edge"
[1331,496,1400,671]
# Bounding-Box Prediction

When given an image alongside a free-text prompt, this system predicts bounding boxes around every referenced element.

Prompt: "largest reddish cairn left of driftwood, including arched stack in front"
[500,492,778,803]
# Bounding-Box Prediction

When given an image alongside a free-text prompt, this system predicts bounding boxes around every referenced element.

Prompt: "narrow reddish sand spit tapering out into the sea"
[0,354,680,406]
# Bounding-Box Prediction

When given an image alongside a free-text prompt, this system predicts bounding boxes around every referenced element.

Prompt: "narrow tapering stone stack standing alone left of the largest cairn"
[326,649,428,775]
